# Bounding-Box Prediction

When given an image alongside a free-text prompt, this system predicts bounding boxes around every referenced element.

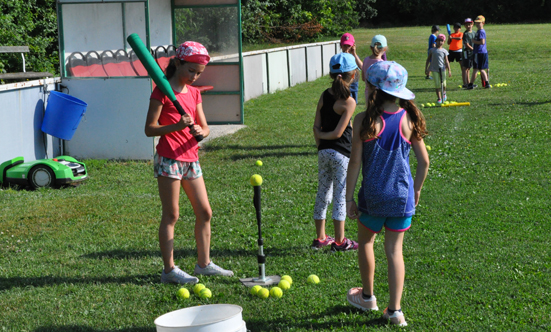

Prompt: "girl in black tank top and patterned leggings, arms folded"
[312,53,358,251]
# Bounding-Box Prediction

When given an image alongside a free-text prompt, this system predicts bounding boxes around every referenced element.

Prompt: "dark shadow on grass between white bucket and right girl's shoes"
[246,305,388,331]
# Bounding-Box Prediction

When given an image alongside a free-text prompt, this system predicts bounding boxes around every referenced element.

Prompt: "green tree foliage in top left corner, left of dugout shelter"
[0,0,59,74]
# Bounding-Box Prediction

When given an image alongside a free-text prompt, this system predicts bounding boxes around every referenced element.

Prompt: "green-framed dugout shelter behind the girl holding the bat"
[57,0,244,160]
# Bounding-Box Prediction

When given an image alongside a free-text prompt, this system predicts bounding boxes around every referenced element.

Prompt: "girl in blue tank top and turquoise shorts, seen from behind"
[346,61,429,326]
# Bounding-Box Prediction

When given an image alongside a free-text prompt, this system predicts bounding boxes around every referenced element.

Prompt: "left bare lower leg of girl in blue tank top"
[358,221,377,296]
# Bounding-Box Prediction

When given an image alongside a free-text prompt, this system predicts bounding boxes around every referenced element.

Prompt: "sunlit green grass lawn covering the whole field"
[0,24,551,332]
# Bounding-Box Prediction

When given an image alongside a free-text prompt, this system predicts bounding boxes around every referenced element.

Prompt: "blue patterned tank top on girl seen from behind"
[358,108,415,217]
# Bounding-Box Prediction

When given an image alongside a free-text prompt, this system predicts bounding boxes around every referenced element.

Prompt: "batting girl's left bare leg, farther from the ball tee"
[157,176,180,273]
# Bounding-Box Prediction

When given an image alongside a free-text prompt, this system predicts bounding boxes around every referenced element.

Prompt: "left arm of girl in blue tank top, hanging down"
[345,112,365,219]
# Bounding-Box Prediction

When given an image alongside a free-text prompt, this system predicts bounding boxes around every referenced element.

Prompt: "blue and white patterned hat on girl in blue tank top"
[367,61,415,100]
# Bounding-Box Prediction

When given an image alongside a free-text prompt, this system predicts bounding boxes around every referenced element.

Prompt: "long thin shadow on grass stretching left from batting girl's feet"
[0,273,159,291]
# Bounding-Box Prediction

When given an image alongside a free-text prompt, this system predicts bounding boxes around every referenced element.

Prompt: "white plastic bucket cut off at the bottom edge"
[155,304,246,332]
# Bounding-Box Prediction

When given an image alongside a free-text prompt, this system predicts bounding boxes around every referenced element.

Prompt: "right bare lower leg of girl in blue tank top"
[385,230,406,310]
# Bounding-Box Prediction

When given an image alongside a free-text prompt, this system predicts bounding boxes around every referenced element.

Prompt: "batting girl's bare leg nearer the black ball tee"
[182,176,212,268]
